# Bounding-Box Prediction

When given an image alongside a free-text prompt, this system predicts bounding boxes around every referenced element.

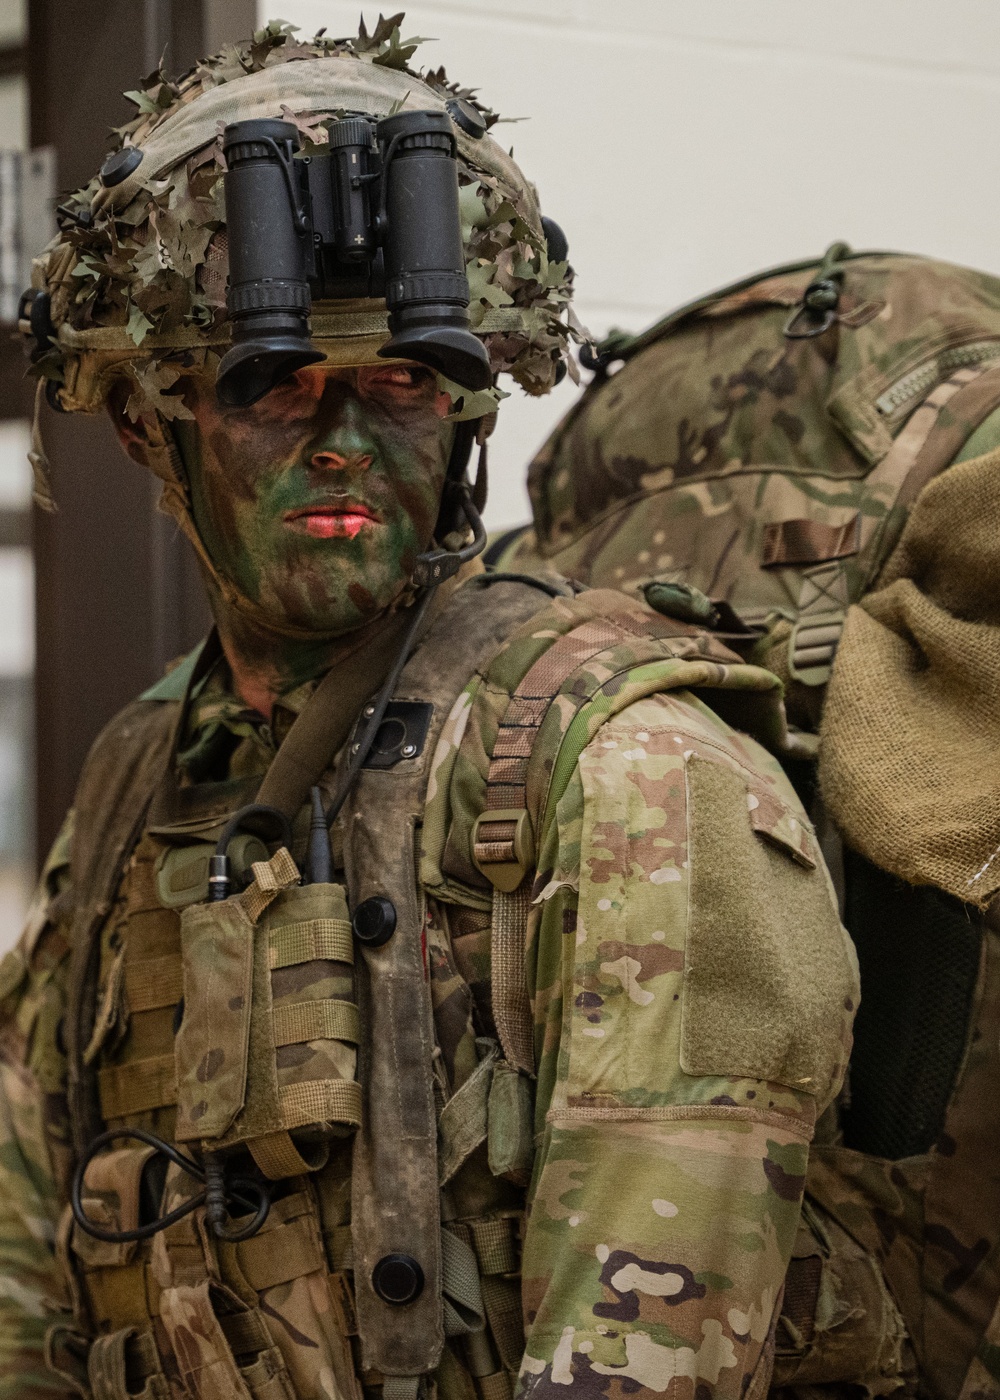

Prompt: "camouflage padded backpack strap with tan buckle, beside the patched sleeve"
[472,589,780,1074]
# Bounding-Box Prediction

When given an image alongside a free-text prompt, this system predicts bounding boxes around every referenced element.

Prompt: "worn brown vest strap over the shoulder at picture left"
[66,700,179,1155]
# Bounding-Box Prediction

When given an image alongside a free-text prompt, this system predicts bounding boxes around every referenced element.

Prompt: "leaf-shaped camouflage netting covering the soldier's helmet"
[25,13,581,416]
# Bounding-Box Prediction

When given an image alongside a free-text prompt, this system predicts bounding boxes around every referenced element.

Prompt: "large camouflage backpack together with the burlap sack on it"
[504,245,1000,1400]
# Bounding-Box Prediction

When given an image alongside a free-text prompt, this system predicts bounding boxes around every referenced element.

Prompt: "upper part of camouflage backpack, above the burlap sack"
[493,244,1000,727]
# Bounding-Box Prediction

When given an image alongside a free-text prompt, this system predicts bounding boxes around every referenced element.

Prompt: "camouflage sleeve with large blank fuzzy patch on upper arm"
[521,696,857,1400]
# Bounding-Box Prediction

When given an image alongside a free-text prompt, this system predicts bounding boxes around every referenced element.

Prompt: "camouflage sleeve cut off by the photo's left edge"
[0,833,71,1400]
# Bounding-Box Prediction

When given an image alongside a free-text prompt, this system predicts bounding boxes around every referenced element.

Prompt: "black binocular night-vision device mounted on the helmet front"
[217,112,493,407]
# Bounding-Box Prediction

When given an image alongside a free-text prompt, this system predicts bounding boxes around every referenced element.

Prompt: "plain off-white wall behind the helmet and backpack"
[259,0,1000,528]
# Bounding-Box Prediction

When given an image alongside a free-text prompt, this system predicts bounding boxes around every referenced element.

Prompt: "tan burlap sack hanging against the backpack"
[819,451,1000,907]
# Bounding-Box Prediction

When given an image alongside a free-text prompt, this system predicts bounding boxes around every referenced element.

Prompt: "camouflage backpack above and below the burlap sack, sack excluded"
[494,245,1000,1400]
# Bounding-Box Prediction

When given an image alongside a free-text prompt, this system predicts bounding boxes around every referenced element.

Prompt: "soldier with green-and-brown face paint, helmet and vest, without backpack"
[0,17,857,1400]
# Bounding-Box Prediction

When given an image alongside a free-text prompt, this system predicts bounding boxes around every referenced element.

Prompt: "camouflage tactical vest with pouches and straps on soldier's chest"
[49,577,780,1400]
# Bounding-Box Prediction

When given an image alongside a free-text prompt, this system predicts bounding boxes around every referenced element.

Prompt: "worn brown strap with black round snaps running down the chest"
[343,578,551,1397]
